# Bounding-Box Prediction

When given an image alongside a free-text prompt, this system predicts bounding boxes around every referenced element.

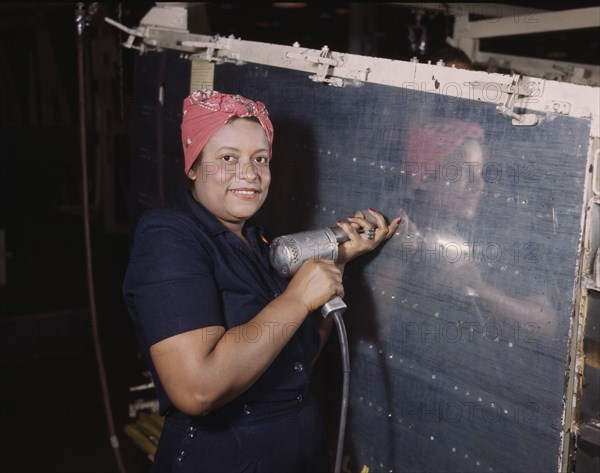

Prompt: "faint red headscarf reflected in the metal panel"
[406,118,483,187]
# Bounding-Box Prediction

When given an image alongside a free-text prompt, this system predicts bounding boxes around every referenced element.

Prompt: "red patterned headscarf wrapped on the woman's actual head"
[181,89,273,174]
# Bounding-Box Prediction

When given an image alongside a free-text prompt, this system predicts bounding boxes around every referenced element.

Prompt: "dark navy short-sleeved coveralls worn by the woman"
[123,192,330,473]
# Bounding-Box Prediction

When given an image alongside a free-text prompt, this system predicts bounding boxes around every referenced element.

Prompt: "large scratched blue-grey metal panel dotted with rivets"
[132,49,590,472]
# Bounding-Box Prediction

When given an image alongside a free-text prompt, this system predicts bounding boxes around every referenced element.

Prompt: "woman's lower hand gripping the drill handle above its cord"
[286,259,344,313]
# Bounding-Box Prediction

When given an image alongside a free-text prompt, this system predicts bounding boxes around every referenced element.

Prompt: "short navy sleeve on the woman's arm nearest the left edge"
[123,212,224,346]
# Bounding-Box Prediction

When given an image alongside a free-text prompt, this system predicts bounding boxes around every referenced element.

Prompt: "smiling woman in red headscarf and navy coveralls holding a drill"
[124,89,398,473]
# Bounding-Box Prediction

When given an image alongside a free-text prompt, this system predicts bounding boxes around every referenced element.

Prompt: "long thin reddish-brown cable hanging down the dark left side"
[75,3,125,473]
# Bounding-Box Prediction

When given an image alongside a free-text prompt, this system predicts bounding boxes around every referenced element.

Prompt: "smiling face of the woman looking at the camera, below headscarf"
[188,118,271,233]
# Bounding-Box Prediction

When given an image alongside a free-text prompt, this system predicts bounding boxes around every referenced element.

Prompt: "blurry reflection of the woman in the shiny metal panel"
[396,119,556,336]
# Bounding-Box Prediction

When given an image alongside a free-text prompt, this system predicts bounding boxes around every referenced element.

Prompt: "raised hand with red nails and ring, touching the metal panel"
[336,209,401,265]
